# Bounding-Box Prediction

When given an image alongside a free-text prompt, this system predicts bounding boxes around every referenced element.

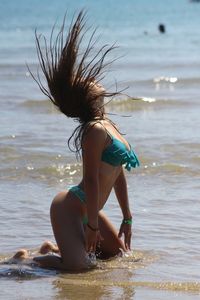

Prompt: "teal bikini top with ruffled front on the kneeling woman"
[101,130,140,171]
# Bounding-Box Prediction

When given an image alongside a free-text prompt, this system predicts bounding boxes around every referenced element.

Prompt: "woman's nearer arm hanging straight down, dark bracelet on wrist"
[83,123,106,251]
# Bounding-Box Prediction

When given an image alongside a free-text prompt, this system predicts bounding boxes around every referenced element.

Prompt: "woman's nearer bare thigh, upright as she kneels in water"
[50,192,86,269]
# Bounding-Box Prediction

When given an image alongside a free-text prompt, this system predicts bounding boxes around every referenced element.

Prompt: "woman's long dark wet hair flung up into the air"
[30,11,118,155]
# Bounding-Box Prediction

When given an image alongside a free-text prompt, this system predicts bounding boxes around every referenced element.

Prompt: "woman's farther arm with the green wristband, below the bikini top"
[114,168,132,250]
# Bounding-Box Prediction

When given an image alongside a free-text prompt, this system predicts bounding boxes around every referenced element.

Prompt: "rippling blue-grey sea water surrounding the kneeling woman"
[0,0,200,300]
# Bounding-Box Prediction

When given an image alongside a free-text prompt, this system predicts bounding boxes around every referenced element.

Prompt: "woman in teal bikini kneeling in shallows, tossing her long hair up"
[28,11,139,271]
